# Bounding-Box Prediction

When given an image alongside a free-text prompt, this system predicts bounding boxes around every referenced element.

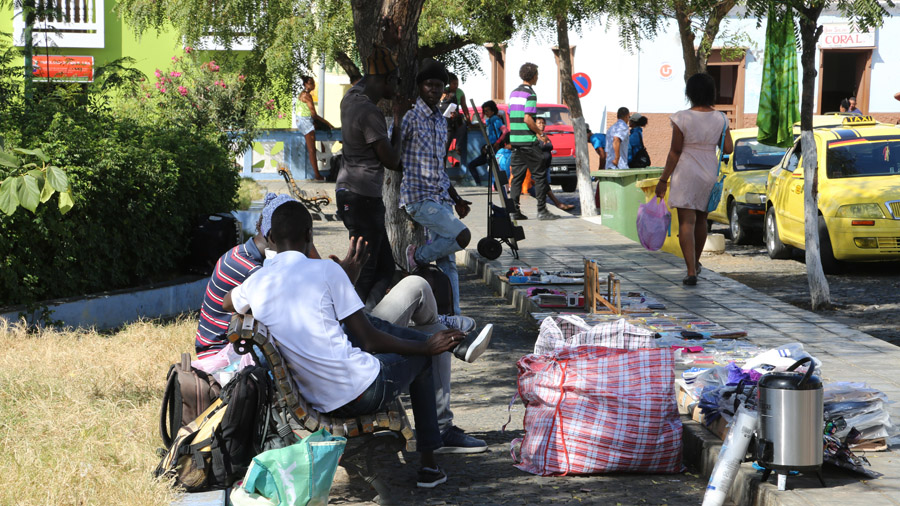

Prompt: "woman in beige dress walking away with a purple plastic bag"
[656,73,733,285]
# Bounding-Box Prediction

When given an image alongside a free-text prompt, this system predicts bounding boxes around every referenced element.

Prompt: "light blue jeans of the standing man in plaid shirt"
[406,200,466,314]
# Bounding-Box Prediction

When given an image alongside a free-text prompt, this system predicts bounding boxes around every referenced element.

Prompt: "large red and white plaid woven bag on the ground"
[511,345,684,476]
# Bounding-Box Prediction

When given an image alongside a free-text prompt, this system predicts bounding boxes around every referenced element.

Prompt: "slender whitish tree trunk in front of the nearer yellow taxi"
[800,7,831,311]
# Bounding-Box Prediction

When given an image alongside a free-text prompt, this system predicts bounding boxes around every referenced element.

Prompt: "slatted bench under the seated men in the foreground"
[226,313,416,504]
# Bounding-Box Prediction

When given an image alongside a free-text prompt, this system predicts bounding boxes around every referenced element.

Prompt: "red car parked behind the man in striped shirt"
[497,104,578,192]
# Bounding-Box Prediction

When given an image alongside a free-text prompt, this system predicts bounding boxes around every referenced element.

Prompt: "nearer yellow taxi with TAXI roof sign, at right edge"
[764,116,900,273]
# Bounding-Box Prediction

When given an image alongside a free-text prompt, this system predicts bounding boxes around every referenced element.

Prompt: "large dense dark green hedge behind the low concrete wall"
[0,109,238,305]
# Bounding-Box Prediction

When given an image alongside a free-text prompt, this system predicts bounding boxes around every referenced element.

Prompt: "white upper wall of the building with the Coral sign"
[461,8,900,121]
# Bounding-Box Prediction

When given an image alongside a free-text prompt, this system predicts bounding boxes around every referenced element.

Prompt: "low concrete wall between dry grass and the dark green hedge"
[0,277,208,330]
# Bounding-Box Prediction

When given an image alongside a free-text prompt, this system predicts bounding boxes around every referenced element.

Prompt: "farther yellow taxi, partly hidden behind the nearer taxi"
[708,117,844,244]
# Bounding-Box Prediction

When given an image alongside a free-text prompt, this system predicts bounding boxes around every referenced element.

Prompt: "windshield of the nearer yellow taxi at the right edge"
[825,137,900,179]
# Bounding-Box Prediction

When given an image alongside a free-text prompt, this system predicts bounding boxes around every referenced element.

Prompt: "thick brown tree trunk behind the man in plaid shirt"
[352,0,425,265]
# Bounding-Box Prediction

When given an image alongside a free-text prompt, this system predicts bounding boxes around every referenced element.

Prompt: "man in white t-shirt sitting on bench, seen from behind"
[223,202,486,488]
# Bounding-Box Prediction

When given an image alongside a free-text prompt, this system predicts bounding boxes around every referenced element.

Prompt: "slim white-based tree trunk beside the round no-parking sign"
[556,13,597,216]
